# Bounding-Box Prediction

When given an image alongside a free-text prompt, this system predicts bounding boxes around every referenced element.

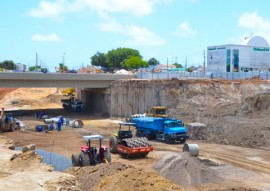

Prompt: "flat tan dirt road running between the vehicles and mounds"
[2,109,270,190]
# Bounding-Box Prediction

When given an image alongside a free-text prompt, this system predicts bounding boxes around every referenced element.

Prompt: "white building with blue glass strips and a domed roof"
[207,36,270,72]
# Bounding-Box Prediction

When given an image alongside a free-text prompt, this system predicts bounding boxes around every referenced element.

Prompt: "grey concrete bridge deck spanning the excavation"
[0,72,135,88]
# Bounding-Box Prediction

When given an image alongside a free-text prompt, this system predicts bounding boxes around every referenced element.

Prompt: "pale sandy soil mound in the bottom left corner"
[0,136,80,191]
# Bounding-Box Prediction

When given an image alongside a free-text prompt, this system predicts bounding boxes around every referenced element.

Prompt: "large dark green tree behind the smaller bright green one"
[106,48,142,71]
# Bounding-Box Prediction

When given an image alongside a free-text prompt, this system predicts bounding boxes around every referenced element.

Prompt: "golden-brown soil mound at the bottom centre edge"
[68,162,186,191]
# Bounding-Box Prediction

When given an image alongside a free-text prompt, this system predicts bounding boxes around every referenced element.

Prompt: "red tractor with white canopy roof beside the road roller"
[71,135,111,166]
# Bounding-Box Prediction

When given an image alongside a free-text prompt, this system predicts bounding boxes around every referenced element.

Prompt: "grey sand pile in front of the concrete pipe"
[153,152,223,186]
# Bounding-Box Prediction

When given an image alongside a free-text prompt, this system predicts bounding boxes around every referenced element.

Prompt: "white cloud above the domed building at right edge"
[238,11,270,42]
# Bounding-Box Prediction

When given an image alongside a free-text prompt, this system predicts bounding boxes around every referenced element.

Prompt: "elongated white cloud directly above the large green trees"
[99,22,166,45]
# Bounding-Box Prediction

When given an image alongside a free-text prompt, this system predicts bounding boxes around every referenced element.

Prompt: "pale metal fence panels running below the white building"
[136,71,270,80]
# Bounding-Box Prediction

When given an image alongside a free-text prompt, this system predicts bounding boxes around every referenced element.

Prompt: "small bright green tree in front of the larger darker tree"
[121,56,148,70]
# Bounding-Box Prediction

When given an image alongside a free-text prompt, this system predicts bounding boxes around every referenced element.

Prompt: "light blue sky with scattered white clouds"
[0,0,270,72]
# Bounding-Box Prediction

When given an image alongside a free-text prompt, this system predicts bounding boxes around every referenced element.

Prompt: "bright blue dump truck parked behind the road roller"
[131,117,188,143]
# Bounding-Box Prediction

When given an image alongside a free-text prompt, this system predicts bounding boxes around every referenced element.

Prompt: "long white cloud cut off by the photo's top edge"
[28,0,171,20]
